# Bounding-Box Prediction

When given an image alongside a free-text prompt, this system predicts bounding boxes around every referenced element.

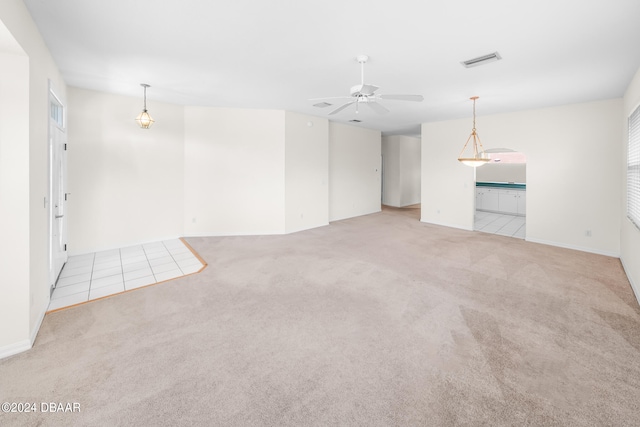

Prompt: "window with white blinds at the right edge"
[627,106,640,229]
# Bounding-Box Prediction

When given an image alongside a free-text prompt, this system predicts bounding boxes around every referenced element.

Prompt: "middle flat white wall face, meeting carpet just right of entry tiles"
[184,107,285,236]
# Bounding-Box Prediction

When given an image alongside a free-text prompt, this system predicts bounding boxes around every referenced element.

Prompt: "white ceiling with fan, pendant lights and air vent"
[24,0,640,134]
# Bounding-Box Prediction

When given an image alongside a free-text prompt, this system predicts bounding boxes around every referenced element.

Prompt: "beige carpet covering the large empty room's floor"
[0,208,640,426]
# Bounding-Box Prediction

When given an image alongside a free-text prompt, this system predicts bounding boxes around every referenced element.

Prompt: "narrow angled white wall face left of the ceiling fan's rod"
[285,112,329,233]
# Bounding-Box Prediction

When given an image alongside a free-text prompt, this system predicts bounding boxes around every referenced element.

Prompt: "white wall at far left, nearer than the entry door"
[0,0,66,357]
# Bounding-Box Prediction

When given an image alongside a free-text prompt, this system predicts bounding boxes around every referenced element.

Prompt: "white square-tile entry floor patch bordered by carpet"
[49,239,203,311]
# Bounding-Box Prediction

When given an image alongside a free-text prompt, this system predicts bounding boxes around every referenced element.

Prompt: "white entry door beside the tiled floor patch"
[49,90,67,290]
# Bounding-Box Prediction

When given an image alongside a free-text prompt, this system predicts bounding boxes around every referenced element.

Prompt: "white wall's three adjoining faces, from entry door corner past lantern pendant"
[68,100,328,244]
